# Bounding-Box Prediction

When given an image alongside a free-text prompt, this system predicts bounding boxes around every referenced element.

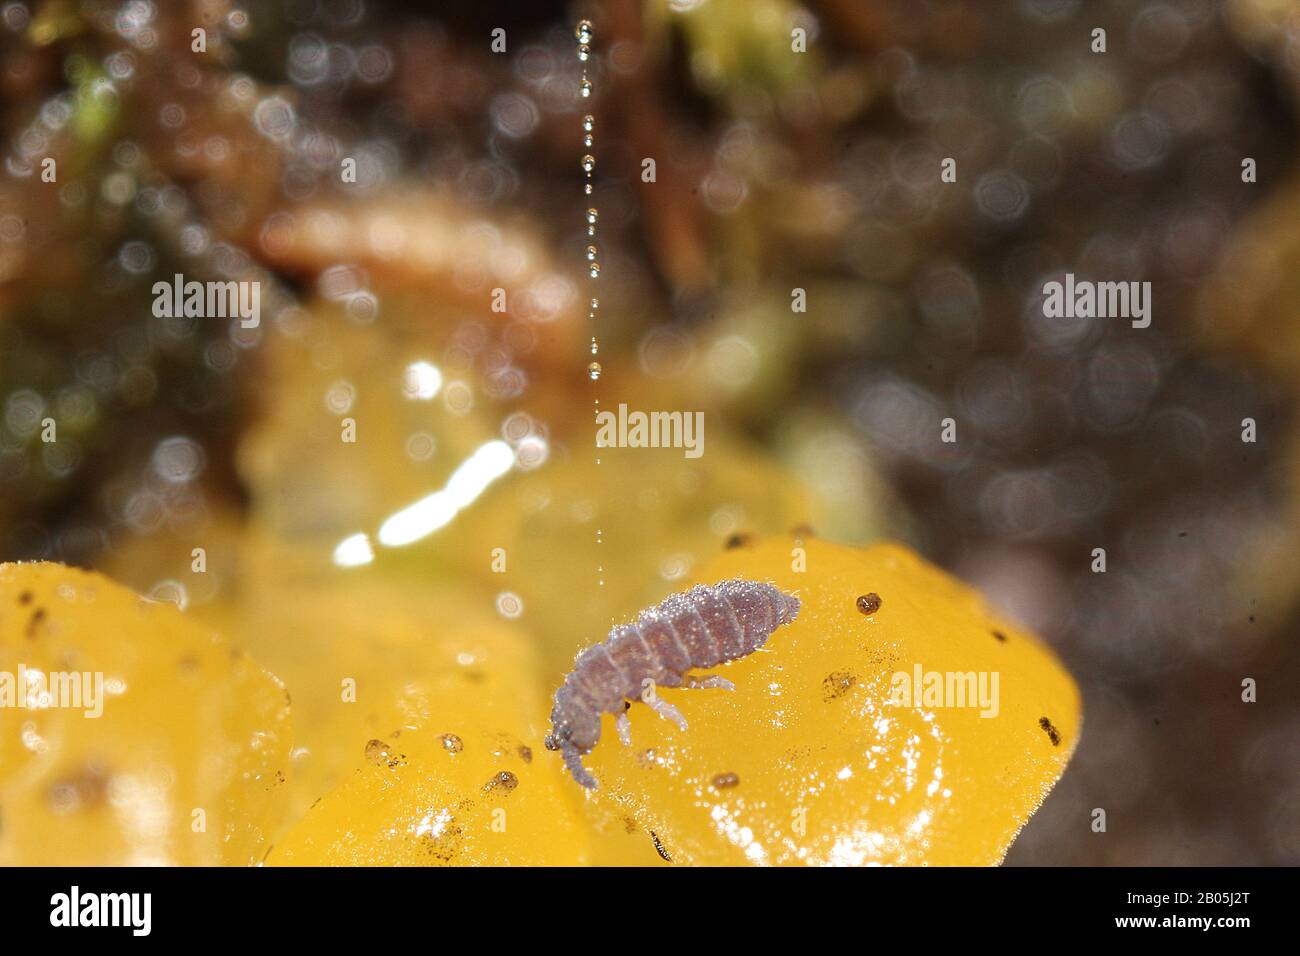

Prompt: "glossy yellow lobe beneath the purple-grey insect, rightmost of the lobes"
[585,538,1082,865]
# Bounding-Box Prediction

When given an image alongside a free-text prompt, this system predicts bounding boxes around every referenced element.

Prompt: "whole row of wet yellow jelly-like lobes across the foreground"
[0,535,1082,865]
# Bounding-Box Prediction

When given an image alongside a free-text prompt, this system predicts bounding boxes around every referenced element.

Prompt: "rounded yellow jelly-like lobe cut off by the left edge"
[0,563,290,866]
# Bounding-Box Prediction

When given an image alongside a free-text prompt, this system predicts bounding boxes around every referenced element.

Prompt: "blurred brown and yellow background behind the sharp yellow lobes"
[0,0,1300,864]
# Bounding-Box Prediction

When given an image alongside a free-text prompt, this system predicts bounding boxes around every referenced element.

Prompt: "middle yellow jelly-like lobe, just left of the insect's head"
[102,529,589,865]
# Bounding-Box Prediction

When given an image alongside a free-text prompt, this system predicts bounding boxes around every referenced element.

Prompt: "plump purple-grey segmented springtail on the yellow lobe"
[546,578,800,790]
